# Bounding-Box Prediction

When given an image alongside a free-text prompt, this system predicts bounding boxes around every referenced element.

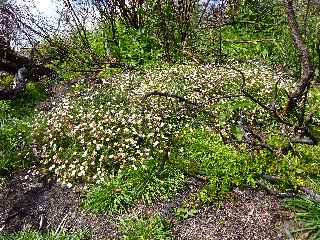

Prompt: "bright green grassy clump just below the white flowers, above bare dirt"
[84,161,184,212]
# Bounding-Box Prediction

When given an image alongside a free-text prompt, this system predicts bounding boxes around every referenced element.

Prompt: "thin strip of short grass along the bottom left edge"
[0,230,88,240]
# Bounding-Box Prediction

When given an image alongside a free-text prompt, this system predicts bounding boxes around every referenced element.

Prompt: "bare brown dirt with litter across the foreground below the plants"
[0,173,290,240]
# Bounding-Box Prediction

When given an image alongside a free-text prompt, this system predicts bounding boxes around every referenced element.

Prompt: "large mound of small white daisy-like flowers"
[33,61,294,185]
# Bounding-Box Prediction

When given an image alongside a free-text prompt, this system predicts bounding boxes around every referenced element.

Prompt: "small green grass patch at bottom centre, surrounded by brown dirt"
[120,216,172,240]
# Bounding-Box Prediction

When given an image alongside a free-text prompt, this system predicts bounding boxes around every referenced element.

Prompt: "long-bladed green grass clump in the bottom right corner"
[286,198,320,240]
